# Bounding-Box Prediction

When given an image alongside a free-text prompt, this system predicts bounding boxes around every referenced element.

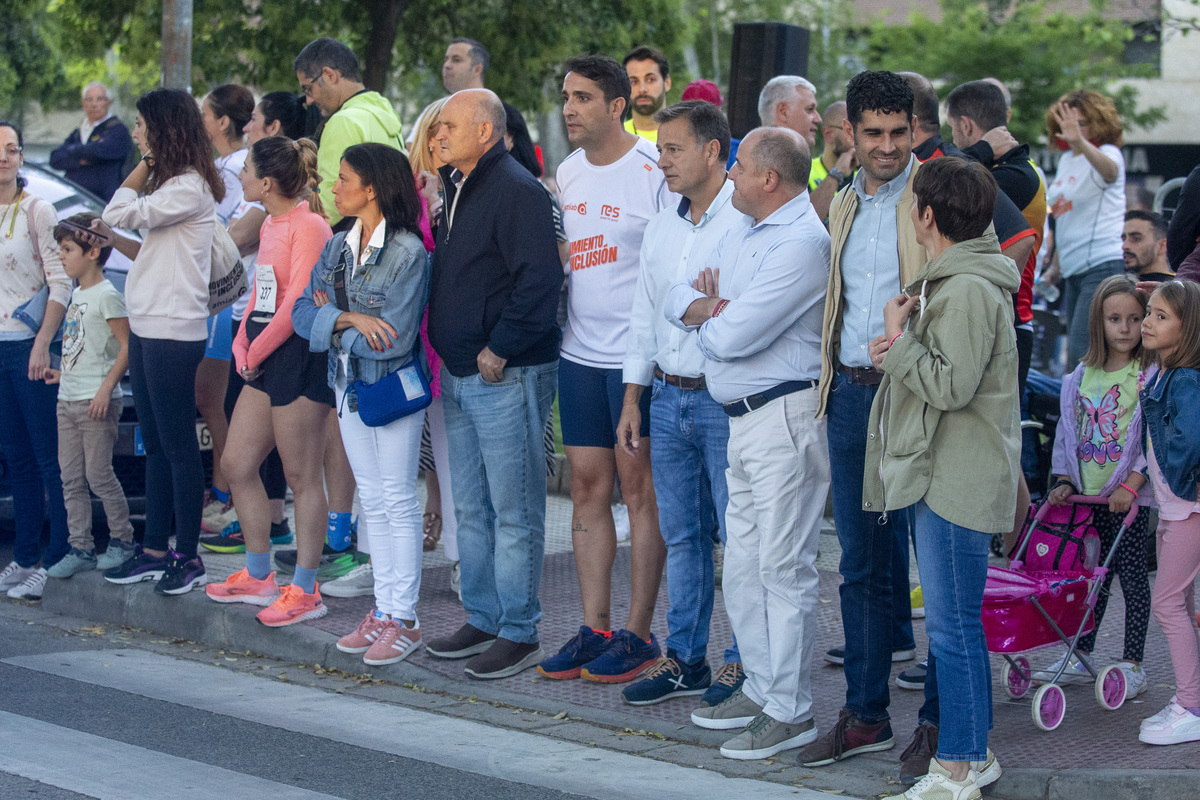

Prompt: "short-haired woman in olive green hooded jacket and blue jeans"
[863,158,1020,799]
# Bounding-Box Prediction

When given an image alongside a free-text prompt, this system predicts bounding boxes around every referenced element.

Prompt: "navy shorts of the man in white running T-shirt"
[558,359,650,449]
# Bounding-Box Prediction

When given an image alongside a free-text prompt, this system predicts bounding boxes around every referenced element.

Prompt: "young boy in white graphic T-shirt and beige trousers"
[46,213,133,578]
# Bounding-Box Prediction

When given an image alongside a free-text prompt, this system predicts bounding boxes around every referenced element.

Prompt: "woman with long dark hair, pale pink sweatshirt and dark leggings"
[92,89,226,595]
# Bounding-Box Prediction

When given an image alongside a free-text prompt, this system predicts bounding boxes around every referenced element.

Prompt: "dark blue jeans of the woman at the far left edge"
[0,338,70,569]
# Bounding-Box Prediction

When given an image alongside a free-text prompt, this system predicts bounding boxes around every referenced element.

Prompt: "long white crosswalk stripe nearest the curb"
[4,650,828,800]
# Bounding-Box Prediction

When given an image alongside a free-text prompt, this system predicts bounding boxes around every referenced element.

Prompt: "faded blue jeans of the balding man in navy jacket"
[442,361,558,643]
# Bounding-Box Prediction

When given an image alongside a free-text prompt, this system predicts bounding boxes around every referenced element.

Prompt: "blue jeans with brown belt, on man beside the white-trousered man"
[649,378,742,664]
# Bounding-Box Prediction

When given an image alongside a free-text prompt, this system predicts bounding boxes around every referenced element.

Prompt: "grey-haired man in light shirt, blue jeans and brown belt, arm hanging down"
[617,101,745,705]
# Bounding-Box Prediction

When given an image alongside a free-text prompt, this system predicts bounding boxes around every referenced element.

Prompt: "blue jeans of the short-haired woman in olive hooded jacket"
[913,500,991,762]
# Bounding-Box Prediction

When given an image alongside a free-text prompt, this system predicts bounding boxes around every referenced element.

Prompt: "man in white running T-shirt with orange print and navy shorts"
[538,55,679,684]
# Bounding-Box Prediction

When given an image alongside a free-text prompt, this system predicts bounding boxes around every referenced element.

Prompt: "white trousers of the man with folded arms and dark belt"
[724,389,829,723]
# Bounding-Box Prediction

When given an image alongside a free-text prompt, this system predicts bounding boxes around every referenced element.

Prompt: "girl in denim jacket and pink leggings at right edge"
[1138,281,1200,745]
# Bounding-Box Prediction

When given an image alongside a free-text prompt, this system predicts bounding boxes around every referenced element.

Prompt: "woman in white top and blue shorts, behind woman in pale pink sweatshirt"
[196,84,254,534]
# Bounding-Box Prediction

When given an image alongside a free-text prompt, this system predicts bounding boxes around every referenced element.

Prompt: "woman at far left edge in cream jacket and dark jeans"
[0,121,71,599]
